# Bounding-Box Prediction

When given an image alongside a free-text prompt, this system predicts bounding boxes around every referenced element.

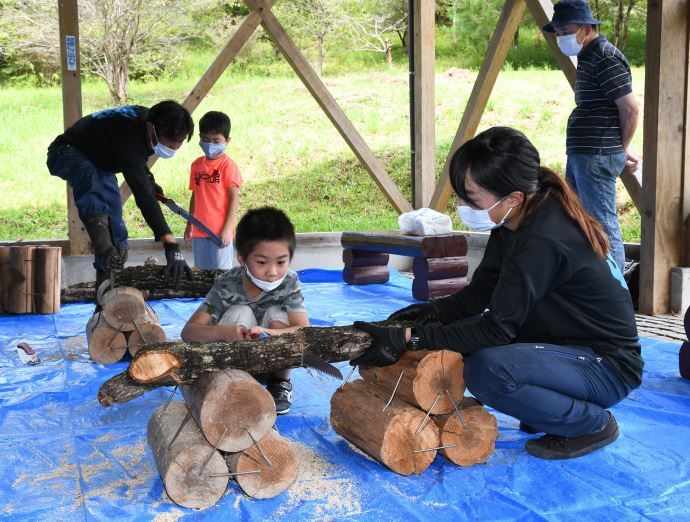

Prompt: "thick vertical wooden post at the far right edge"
[640,0,688,315]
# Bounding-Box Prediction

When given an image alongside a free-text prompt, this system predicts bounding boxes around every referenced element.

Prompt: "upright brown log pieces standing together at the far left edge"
[0,245,62,314]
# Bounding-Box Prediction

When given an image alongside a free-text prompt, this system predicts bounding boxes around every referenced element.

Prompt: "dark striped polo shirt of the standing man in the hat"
[566,36,632,154]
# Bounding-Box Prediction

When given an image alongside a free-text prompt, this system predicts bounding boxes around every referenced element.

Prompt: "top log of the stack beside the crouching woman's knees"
[359,350,465,414]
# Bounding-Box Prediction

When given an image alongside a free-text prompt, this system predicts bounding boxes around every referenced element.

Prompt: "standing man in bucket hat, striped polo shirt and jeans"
[543,0,639,272]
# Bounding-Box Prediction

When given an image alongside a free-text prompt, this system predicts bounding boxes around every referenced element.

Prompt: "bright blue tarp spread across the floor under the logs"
[0,270,690,521]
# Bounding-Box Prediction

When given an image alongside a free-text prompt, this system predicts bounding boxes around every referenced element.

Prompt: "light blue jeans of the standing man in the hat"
[565,152,626,273]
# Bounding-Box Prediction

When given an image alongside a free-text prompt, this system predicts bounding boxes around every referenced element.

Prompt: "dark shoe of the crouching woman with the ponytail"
[525,413,619,460]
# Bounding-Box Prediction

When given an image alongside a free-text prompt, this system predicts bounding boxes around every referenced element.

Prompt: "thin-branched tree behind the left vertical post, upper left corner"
[2,0,186,104]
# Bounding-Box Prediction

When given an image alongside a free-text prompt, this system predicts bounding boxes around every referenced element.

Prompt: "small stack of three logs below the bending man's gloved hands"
[86,282,166,364]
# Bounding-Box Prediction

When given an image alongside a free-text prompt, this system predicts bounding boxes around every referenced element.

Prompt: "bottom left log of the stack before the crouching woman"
[331,379,440,475]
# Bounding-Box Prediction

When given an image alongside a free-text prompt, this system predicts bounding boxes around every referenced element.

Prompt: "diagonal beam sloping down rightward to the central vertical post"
[245,0,412,212]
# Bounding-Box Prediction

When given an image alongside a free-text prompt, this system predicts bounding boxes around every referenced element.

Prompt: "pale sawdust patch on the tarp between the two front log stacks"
[274,442,362,521]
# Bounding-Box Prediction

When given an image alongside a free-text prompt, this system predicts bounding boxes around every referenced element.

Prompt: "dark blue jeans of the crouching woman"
[464,343,632,438]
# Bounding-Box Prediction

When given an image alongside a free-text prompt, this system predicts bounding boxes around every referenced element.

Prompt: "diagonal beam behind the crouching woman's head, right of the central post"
[429,0,525,212]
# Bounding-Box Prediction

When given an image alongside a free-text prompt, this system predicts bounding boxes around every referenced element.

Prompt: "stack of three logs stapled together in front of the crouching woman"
[331,350,498,475]
